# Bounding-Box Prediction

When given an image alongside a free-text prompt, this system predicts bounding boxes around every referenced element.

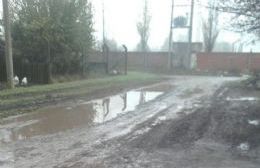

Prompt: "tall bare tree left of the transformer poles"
[136,0,151,52]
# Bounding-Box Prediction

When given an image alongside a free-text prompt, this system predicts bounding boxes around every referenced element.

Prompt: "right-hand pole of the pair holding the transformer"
[187,0,194,69]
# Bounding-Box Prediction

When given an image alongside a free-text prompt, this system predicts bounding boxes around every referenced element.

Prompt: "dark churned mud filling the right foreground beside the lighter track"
[85,80,260,168]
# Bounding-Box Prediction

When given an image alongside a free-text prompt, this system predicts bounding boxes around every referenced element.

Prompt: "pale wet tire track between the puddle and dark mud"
[3,77,239,168]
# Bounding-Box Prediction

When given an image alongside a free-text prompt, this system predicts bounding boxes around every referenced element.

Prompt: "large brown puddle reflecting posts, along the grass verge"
[0,84,173,143]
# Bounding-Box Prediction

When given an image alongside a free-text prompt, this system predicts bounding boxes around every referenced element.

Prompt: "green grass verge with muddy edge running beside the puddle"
[0,72,162,118]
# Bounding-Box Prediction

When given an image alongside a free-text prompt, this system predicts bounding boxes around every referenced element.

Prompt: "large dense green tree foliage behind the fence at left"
[12,0,94,73]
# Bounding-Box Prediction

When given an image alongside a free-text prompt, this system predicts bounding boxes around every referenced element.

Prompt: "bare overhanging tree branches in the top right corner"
[218,0,260,36]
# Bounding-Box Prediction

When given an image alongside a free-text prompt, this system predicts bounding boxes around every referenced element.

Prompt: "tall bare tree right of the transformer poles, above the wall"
[203,1,219,52]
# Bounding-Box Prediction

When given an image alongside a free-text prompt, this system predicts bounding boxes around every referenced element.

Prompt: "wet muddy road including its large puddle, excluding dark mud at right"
[0,76,248,168]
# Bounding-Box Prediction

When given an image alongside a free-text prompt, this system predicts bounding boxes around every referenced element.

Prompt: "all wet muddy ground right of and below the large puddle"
[0,76,247,168]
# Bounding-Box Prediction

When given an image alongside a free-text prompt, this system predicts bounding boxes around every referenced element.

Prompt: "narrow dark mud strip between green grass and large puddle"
[0,78,162,119]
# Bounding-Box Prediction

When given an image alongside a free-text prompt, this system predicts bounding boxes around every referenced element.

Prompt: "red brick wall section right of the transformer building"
[197,53,260,71]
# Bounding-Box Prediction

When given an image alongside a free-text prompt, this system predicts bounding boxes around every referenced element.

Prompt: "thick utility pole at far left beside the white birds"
[2,0,14,89]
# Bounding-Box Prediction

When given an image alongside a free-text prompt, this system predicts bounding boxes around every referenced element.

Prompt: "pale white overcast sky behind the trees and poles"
[0,0,243,50]
